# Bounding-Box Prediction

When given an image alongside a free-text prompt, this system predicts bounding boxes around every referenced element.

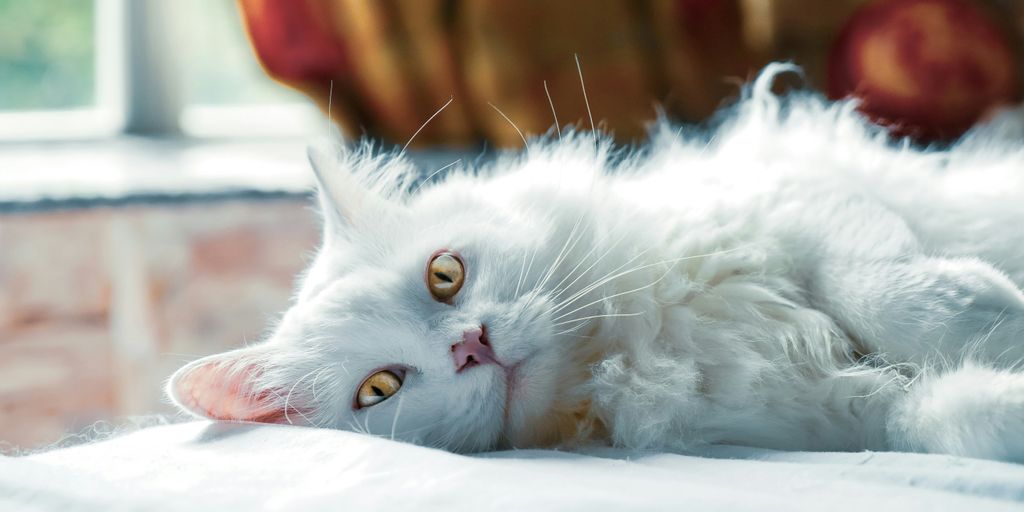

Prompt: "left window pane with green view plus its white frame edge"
[0,0,124,139]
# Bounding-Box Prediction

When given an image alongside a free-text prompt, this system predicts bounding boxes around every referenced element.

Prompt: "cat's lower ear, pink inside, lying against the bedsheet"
[167,347,303,423]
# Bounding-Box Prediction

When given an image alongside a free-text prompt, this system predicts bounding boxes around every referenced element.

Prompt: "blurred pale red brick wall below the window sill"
[0,199,317,447]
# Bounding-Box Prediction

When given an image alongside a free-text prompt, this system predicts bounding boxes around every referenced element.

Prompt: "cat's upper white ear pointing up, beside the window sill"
[306,143,393,238]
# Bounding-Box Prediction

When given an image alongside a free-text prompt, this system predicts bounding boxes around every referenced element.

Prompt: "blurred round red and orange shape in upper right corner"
[828,0,1022,141]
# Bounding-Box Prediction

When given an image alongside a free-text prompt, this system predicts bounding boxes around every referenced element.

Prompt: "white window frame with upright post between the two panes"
[0,0,323,144]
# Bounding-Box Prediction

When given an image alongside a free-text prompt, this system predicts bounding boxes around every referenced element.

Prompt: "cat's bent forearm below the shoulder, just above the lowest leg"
[811,255,1024,367]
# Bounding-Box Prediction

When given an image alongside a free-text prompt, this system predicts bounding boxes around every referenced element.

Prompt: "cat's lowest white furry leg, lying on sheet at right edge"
[887,364,1024,462]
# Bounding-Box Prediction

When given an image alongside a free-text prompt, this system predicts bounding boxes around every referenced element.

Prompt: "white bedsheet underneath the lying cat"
[0,422,1024,512]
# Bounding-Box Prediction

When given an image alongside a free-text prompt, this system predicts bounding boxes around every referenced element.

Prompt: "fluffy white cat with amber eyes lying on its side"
[168,65,1024,462]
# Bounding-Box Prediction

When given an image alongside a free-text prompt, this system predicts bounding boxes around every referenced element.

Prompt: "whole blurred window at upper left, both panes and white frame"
[0,0,324,140]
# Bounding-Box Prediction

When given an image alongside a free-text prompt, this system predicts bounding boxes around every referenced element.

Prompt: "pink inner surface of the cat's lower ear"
[171,358,290,423]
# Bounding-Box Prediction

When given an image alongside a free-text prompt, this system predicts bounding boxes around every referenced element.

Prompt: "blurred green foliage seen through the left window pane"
[0,0,95,111]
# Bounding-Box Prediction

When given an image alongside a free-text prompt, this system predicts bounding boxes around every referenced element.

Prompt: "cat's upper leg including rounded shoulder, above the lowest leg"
[790,198,1024,367]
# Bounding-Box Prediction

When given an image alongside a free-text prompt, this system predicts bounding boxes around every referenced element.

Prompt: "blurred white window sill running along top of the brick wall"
[0,137,468,213]
